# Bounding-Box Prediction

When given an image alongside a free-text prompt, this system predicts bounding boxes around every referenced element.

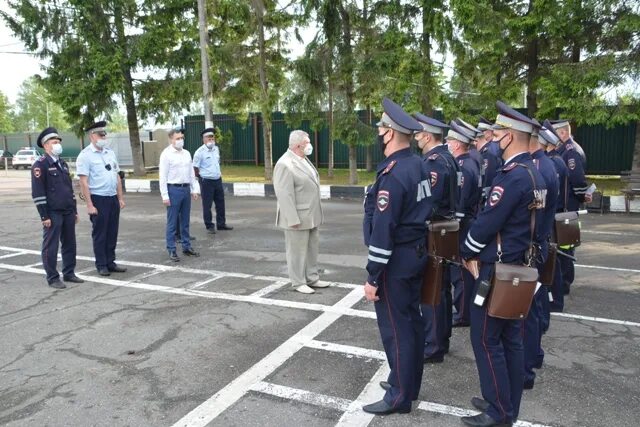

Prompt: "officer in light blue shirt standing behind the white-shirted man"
[193,128,233,234]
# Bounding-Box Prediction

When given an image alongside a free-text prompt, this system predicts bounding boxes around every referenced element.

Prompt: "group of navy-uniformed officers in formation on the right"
[363,98,591,426]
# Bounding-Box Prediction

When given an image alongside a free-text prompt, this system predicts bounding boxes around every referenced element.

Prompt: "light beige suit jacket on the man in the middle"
[273,150,323,230]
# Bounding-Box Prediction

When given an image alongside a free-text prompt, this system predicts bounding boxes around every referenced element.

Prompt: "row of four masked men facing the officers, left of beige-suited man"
[31,121,233,289]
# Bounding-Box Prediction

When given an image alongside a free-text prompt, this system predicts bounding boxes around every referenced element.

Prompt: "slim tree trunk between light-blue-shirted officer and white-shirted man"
[114,7,147,176]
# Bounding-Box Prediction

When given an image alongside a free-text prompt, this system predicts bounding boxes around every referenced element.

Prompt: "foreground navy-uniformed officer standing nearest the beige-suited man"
[362,98,432,415]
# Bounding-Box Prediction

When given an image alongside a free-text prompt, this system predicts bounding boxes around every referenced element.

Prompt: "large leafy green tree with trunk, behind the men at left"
[0,0,197,175]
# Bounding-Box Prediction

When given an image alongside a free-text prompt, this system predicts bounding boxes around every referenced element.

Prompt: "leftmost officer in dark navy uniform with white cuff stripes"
[31,127,84,289]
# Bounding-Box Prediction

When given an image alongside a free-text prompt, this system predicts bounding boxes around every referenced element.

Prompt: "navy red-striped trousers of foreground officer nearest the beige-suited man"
[375,240,427,409]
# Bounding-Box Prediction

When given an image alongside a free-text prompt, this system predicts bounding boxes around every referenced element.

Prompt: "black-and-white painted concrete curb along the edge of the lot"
[125,178,640,213]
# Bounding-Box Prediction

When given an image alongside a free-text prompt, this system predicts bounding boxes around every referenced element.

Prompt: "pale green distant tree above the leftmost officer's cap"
[14,76,69,132]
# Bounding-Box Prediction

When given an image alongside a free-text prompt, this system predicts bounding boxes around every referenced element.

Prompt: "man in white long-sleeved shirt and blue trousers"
[160,129,200,262]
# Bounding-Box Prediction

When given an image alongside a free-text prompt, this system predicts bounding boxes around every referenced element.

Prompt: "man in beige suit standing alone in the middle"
[273,130,328,294]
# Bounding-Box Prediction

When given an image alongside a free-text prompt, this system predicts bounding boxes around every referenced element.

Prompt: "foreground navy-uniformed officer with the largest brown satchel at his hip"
[461,101,546,427]
